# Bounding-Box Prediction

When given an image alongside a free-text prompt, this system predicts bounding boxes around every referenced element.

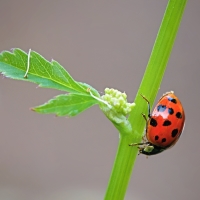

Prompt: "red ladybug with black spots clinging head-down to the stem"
[130,91,185,156]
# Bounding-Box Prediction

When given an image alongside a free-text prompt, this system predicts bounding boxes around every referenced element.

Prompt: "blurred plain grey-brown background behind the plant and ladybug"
[0,0,200,200]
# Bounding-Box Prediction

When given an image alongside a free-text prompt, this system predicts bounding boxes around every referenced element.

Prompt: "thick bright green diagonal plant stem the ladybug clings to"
[104,0,187,200]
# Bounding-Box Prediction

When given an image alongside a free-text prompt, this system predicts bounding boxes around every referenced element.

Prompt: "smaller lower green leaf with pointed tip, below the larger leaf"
[32,93,99,117]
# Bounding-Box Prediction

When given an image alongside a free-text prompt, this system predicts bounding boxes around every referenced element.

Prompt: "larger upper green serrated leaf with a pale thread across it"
[0,49,99,96]
